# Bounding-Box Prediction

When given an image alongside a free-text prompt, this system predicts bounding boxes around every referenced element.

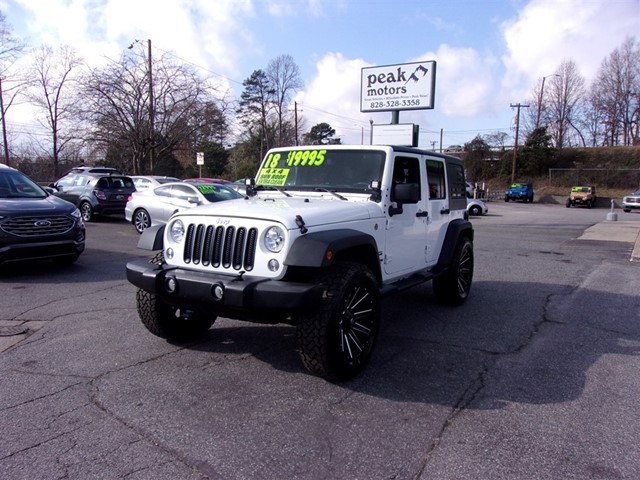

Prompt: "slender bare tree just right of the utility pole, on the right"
[545,60,585,148]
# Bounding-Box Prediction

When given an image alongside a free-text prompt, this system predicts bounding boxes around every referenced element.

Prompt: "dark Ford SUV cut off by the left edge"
[0,164,85,265]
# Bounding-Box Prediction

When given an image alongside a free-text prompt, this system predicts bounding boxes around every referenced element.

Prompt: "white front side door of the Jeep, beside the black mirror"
[384,154,427,275]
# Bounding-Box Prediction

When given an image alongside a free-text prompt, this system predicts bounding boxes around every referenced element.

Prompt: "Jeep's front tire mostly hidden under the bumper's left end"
[136,252,216,341]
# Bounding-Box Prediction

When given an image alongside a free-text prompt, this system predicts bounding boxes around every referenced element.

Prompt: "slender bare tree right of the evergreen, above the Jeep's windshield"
[266,55,303,146]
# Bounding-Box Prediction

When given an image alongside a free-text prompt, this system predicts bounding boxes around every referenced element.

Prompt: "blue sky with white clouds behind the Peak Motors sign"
[0,0,640,149]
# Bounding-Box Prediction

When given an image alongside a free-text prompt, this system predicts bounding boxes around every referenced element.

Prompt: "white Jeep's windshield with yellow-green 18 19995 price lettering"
[256,148,385,192]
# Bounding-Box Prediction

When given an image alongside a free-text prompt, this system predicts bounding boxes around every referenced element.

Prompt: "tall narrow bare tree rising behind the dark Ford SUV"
[28,45,83,176]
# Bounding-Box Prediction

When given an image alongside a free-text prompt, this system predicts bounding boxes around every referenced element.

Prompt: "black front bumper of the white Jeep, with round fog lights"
[127,260,325,317]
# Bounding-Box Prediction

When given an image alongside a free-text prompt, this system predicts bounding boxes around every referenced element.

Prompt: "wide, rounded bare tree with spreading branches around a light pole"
[83,45,221,174]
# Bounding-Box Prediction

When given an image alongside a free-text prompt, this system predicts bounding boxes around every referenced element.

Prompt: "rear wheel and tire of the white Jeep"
[433,237,473,305]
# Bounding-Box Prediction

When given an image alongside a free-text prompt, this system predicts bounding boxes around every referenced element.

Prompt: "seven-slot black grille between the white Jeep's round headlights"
[184,224,258,272]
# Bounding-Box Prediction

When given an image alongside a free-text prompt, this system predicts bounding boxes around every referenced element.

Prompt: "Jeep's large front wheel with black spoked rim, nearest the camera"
[297,262,381,380]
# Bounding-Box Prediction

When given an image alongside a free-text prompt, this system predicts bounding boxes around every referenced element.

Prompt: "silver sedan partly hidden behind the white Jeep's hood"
[124,182,243,233]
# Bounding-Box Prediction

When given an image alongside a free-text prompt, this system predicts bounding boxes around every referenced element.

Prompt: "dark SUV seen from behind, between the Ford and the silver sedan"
[49,171,136,222]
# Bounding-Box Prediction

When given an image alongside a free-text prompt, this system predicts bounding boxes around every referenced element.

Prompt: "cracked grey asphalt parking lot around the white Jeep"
[0,202,640,479]
